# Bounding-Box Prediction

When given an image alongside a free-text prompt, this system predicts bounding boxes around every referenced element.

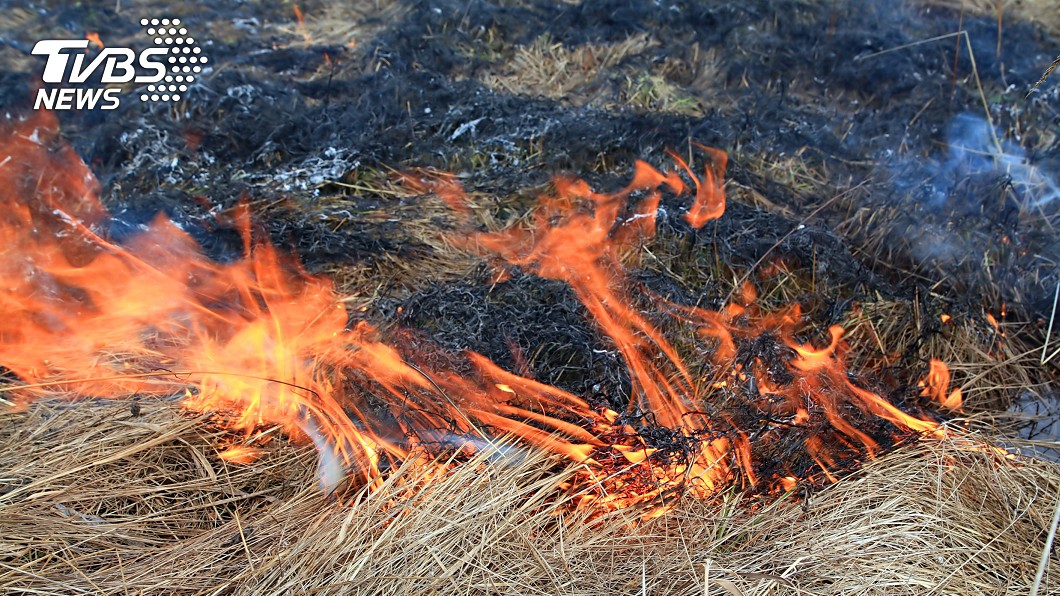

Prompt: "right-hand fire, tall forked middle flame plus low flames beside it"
[472,147,940,492]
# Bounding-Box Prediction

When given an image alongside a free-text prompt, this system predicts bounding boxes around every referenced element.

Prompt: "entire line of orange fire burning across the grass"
[0,113,959,512]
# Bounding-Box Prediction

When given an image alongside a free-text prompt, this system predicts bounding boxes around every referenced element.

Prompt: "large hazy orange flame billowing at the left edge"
[0,115,374,487]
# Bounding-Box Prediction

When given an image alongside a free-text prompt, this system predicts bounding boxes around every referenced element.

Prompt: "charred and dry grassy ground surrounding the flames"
[0,0,1060,594]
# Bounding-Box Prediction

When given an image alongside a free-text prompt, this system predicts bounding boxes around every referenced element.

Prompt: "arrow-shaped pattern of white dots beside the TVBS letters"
[140,18,207,102]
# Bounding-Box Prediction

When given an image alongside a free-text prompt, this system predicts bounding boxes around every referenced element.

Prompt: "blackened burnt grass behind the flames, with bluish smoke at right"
[0,0,1060,487]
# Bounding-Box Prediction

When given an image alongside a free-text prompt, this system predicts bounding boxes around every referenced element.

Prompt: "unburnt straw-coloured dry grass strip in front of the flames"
[0,392,1060,594]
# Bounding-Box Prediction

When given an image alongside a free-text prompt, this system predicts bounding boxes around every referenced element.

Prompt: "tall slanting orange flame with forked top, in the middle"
[473,156,695,427]
